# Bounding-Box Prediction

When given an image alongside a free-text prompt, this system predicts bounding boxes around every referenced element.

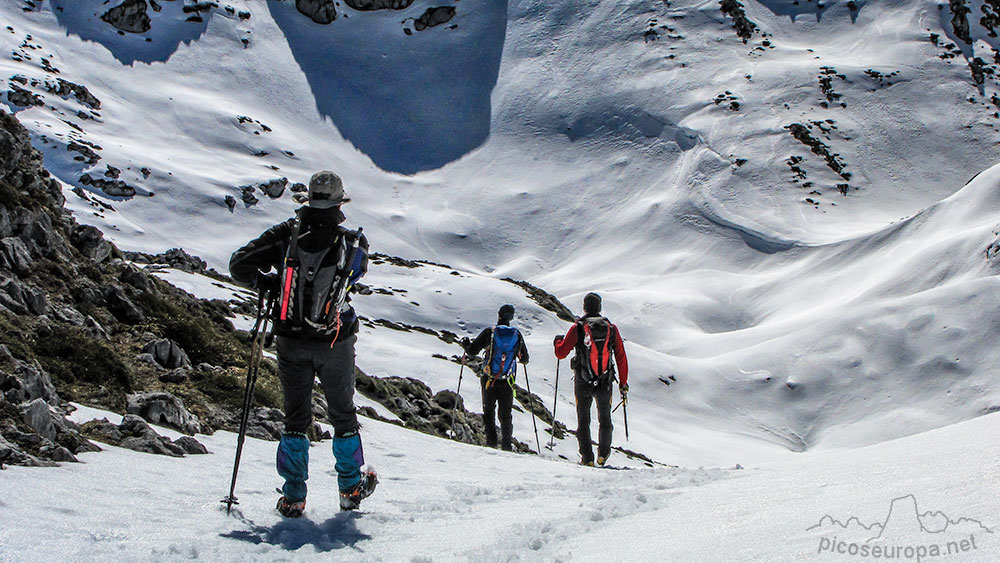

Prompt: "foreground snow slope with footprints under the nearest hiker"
[0,411,1000,563]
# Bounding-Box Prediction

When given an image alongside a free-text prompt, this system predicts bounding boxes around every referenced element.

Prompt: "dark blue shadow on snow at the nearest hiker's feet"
[219,512,372,552]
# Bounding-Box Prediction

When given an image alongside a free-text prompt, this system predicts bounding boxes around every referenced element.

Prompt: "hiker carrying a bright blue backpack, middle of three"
[463,305,528,451]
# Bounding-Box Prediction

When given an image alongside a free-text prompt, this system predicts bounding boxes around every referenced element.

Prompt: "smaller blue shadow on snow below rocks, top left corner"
[49,0,214,66]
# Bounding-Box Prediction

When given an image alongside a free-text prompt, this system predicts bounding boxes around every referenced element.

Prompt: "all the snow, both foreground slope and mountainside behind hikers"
[0,0,1000,561]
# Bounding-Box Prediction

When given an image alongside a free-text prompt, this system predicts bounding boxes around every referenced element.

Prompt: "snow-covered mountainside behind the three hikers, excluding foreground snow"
[0,0,1000,465]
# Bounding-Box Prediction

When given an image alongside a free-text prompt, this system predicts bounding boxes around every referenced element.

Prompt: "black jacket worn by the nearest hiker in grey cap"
[229,207,368,340]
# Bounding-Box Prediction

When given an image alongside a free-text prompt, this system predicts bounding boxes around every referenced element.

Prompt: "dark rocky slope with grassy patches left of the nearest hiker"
[0,109,290,465]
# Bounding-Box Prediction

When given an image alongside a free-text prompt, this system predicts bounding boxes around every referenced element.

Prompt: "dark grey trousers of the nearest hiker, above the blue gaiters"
[277,335,358,436]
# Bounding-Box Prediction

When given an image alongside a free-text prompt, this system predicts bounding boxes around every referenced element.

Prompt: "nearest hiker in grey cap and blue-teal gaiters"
[229,171,378,516]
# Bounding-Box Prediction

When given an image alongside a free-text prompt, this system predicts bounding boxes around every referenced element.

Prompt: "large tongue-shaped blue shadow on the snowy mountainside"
[268,0,507,174]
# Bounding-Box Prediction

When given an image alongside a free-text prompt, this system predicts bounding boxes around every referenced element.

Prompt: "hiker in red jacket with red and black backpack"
[554,293,628,465]
